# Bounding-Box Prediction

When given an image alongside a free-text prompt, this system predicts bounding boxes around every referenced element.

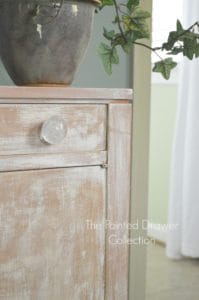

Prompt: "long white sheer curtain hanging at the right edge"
[167,0,199,259]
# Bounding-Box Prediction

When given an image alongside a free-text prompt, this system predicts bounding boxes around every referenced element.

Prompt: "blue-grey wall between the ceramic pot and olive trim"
[73,8,132,88]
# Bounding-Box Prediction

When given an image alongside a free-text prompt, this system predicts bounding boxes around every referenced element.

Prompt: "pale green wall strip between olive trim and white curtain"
[148,84,177,224]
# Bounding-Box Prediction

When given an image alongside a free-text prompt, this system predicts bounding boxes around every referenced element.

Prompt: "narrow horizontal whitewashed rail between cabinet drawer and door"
[0,151,107,172]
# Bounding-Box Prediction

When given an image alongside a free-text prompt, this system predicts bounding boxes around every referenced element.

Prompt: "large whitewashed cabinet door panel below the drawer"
[0,166,106,300]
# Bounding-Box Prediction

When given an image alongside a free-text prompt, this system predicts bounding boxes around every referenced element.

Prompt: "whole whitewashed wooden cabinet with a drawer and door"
[0,87,132,300]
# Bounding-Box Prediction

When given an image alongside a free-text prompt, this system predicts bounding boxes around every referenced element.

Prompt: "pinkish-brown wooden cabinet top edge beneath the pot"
[0,86,133,101]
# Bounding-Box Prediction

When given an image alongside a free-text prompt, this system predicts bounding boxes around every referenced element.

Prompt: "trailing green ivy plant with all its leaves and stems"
[98,0,199,80]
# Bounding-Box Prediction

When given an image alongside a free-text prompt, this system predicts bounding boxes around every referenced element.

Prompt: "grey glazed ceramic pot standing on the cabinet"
[0,0,97,86]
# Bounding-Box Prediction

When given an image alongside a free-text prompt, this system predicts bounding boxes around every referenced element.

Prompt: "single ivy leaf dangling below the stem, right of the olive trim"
[153,58,177,80]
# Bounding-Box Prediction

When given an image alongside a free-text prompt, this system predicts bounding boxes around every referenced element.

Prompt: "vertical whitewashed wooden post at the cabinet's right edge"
[105,104,132,300]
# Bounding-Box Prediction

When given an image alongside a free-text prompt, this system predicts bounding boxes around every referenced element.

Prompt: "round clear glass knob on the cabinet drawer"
[40,116,67,145]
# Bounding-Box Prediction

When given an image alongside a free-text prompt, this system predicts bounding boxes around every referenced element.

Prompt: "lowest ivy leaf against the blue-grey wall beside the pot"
[99,43,119,75]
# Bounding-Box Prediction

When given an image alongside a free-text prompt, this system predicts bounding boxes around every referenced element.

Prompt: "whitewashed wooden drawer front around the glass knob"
[0,104,107,155]
